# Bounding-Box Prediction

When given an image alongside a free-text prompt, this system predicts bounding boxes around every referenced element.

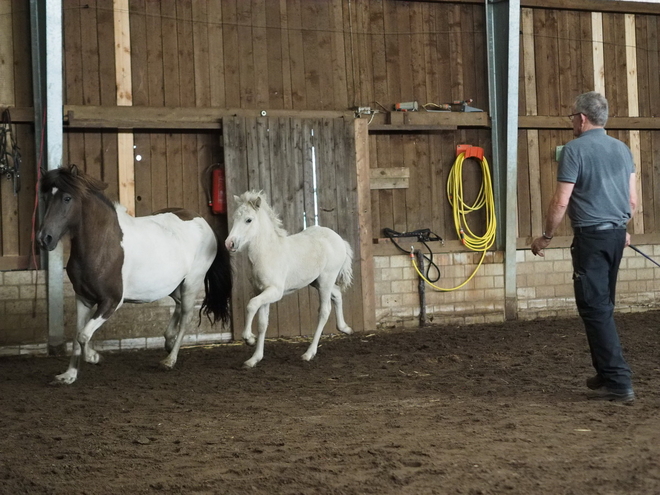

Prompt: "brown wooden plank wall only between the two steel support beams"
[59,0,490,244]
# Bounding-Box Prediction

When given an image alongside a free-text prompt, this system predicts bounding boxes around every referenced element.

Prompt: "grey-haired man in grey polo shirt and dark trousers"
[532,91,637,402]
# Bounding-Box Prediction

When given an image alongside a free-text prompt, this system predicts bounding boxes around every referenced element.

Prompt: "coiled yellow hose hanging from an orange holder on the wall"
[410,152,497,292]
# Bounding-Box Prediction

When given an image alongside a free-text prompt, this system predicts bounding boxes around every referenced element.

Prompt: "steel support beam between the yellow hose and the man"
[485,0,520,320]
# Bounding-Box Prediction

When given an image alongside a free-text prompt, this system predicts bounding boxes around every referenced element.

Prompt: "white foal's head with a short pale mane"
[225,191,287,251]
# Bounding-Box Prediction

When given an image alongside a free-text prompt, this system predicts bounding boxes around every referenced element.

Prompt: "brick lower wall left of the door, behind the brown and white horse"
[0,271,231,355]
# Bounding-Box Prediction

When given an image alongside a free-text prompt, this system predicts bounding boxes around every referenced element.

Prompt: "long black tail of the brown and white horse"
[199,239,232,324]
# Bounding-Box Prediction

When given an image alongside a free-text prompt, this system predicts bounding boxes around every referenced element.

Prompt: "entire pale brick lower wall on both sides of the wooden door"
[5,245,660,355]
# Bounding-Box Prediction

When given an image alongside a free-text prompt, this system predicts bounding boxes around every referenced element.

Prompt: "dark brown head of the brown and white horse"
[37,165,112,251]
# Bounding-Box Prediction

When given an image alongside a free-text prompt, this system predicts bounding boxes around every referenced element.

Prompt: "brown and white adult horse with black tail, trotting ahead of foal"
[38,165,232,384]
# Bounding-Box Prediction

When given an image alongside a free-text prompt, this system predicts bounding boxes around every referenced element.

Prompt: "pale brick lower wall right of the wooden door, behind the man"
[374,245,660,327]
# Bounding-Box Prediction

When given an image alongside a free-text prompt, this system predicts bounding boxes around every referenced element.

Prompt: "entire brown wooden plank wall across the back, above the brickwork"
[5,0,660,272]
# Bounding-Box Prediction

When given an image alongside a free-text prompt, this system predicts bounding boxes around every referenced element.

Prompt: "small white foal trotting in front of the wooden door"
[225,191,353,368]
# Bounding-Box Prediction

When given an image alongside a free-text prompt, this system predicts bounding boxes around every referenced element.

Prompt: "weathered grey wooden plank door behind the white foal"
[223,117,375,339]
